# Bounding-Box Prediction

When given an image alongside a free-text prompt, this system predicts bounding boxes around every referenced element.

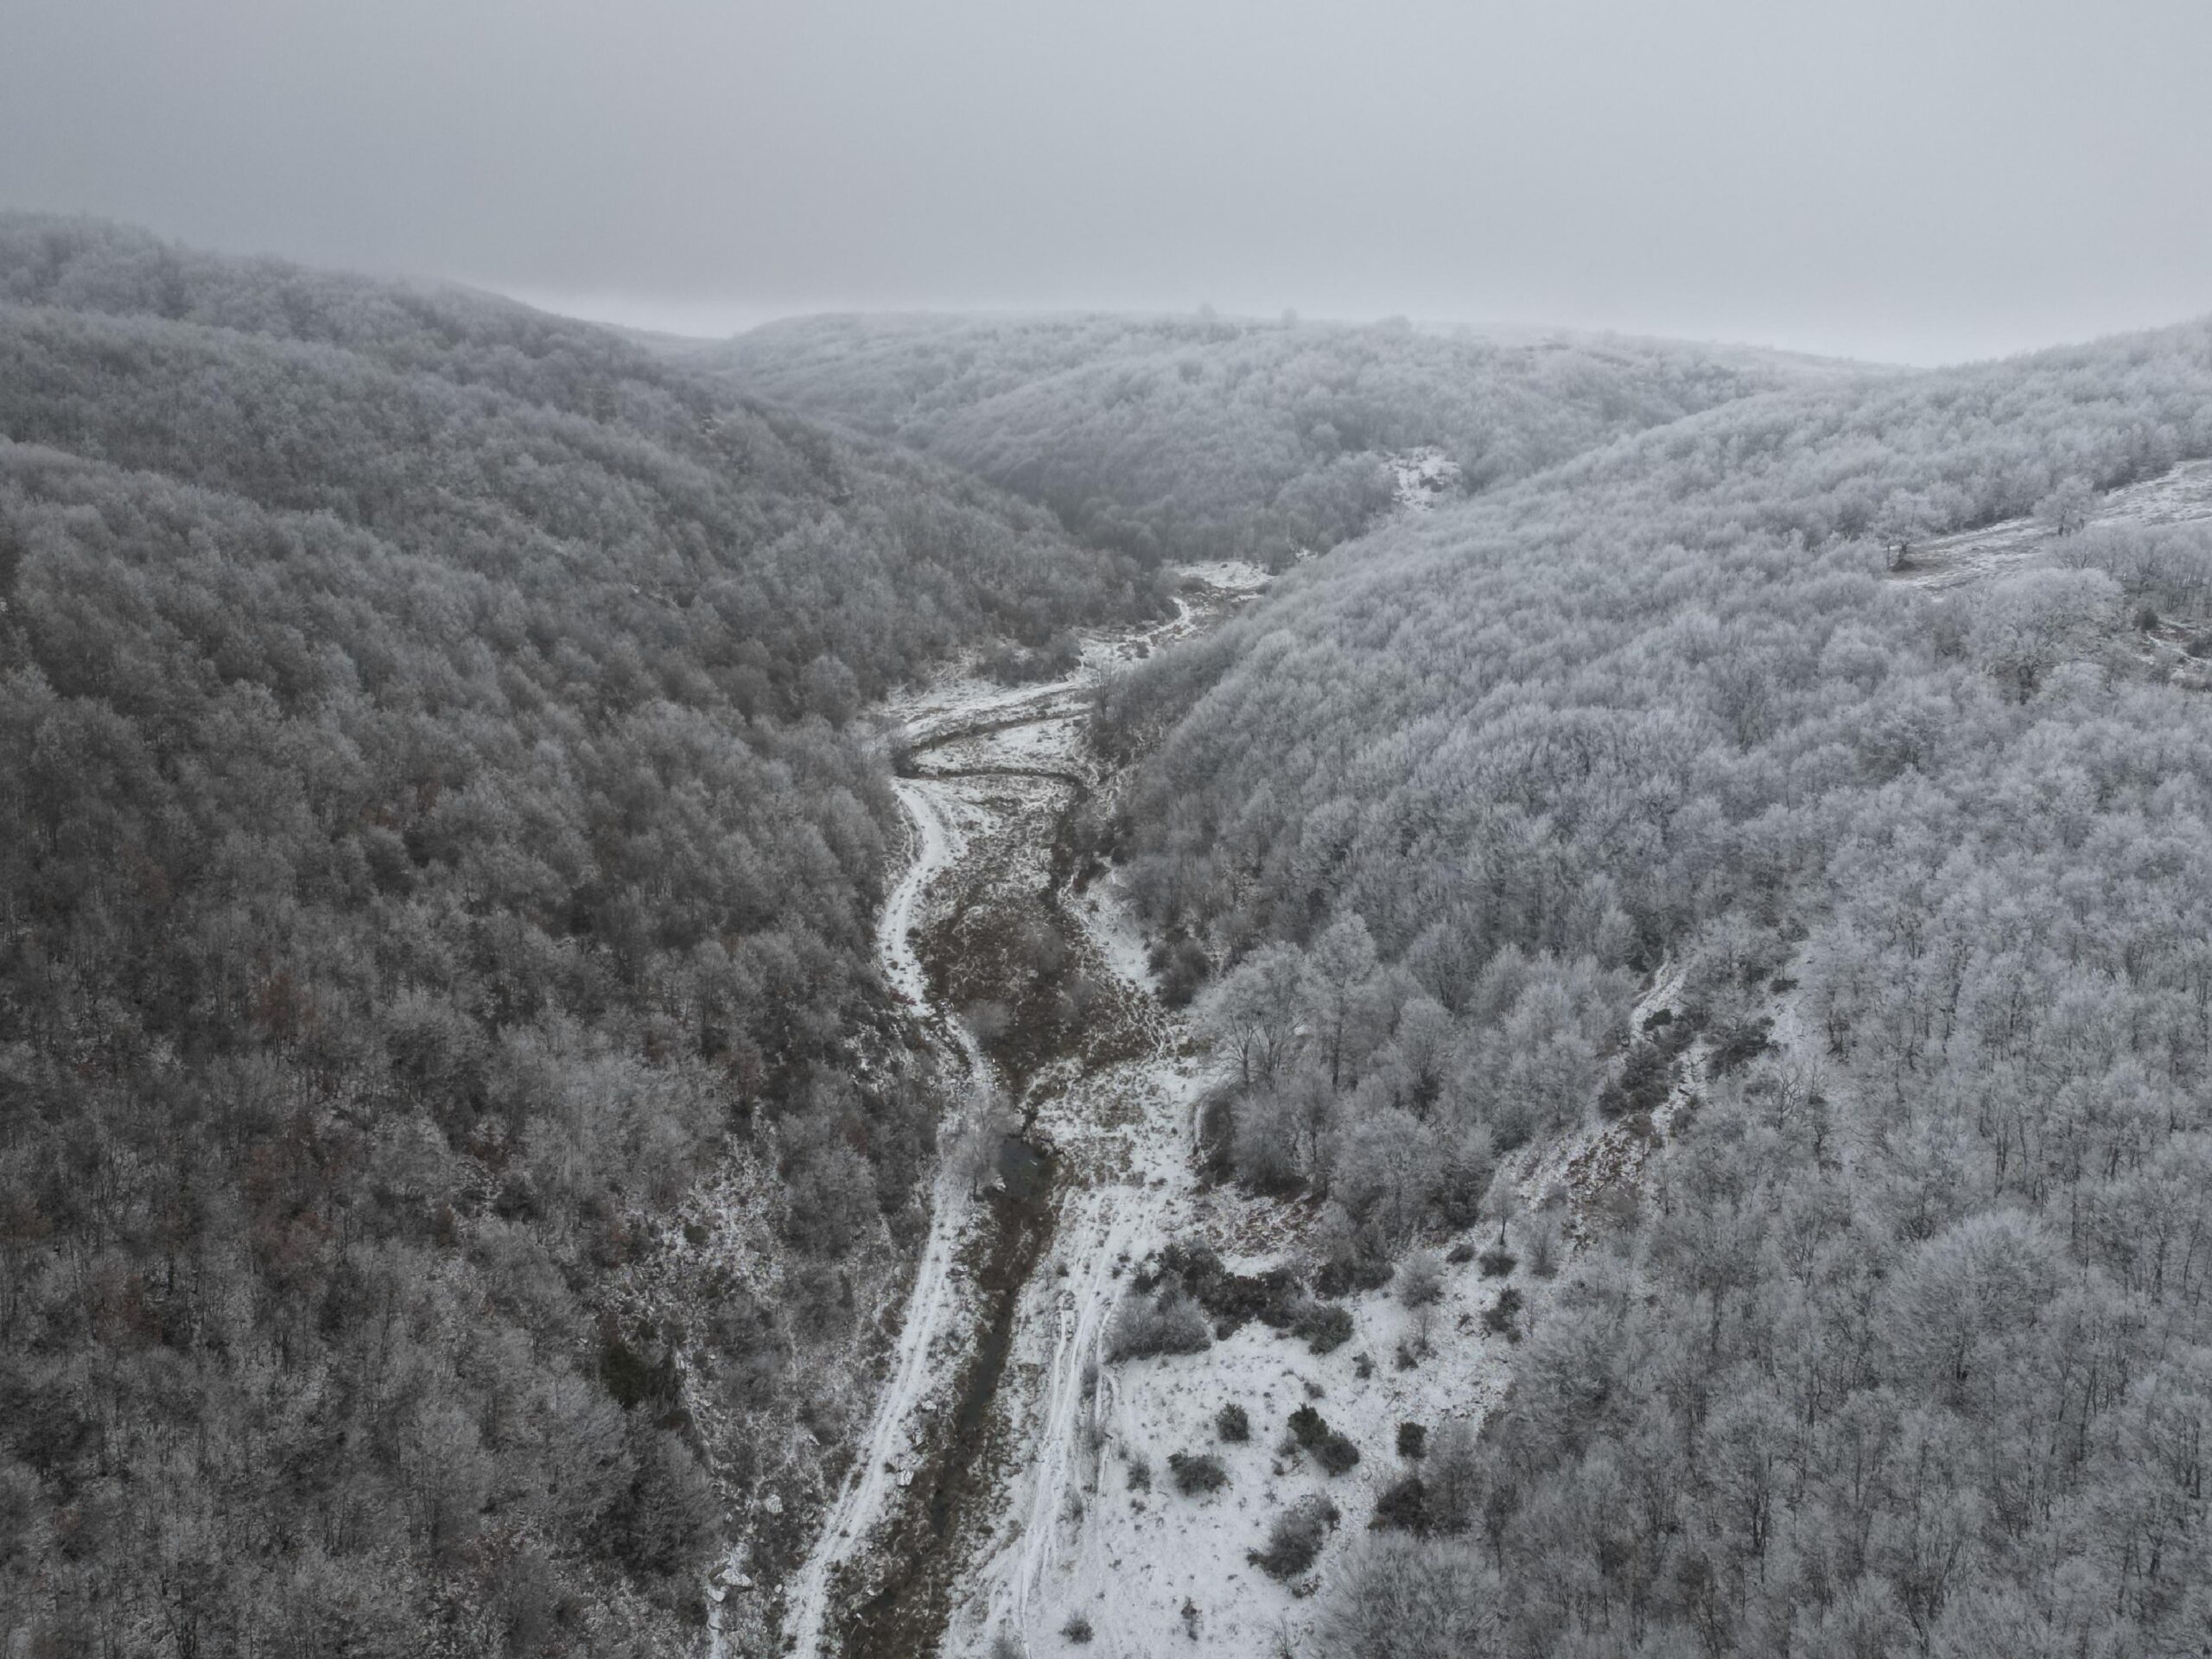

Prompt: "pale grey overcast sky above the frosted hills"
[0,0,2212,363]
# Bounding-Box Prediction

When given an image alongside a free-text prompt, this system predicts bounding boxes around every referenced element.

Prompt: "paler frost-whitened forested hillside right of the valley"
[1099,323,2212,1656]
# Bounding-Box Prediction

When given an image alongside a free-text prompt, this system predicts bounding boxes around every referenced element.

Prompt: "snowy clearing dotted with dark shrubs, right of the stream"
[944,858,1541,1659]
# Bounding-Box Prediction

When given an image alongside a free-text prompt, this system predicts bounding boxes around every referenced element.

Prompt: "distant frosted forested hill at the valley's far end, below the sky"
[686,316,1847,564]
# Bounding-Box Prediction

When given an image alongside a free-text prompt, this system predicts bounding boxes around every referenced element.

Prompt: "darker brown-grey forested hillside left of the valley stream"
[0,217,1159,1655]
